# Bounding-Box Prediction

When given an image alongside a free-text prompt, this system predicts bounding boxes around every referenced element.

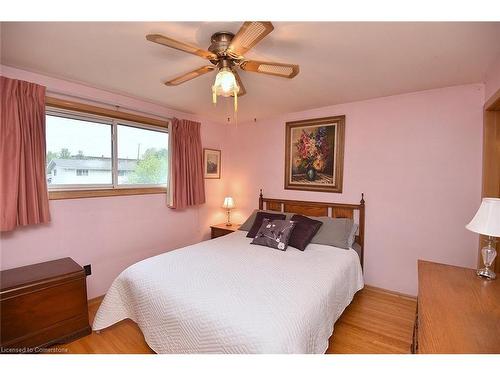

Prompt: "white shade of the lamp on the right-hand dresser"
[465,198,500,237]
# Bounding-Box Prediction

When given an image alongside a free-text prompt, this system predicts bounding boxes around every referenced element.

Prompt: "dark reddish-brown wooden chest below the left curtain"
[0,258,91,353]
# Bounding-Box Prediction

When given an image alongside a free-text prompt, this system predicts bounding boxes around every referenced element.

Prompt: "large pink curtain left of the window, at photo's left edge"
[0,77,50,231]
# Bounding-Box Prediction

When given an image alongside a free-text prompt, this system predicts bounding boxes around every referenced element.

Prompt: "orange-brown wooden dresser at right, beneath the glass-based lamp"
[412,260,500,354]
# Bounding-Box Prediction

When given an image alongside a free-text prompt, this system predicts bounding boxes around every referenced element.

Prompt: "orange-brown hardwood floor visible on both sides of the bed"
[54,286,416,354]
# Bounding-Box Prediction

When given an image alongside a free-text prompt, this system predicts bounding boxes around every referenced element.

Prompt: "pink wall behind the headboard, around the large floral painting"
[228,84,484,294]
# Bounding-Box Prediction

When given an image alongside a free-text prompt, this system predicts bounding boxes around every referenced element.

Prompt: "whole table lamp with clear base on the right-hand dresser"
[465,198,500,280]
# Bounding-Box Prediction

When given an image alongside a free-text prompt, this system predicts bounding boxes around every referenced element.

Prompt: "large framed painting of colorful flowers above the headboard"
[285,116,345,193]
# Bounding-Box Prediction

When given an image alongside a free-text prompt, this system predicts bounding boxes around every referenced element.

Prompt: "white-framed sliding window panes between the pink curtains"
[46,108,168,195]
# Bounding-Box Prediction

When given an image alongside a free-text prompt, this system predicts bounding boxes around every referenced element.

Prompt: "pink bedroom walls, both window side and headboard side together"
[0,66,488,298]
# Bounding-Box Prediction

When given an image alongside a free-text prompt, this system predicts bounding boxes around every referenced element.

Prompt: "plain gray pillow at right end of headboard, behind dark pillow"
[311,217,358,249]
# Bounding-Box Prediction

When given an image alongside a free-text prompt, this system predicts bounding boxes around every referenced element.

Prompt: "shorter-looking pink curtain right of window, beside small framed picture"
[169,118,205,209]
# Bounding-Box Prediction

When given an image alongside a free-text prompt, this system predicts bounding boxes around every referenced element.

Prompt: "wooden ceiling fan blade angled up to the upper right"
[227,21,274,57]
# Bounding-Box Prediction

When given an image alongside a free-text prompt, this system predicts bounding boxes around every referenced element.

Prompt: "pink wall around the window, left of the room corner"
[0,66,227,298]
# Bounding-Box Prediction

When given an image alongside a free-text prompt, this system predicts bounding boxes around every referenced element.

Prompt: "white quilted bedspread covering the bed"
[93,231,363,353]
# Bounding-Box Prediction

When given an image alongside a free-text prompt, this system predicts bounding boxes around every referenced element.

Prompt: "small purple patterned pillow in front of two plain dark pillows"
[251,219,295,251]
